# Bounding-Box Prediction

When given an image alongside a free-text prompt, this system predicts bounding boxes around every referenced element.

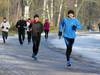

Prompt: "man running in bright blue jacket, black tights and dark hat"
[58,10,81,66]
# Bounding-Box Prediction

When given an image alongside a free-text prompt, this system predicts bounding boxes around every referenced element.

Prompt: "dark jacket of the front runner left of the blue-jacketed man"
[31,22,43,36]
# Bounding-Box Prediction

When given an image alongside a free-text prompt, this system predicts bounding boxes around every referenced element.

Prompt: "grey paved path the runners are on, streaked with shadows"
[0,37,100,75]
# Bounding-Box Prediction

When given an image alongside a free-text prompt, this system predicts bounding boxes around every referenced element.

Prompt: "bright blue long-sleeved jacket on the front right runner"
[59,18,81,38]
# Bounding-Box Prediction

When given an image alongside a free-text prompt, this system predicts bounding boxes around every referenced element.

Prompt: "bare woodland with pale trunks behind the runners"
[0,0,100,29]
